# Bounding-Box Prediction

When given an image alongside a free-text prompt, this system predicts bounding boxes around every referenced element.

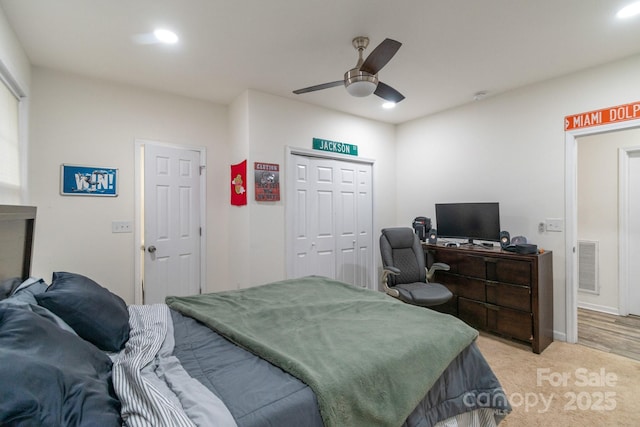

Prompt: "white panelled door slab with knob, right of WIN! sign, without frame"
[143,144,201,304]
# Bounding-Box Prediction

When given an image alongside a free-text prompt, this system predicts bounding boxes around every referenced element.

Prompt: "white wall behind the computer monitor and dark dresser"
[396,52,640,336]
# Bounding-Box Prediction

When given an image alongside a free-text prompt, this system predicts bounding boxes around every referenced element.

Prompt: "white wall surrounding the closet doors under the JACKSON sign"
[238,91,396,286]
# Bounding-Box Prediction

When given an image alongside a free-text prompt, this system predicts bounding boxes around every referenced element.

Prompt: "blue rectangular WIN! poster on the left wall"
[60,164,118,197]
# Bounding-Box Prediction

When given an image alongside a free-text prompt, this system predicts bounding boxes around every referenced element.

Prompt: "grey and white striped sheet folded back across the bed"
[113,304,236,427]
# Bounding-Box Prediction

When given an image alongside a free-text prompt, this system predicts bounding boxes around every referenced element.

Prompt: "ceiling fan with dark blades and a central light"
[293,37,404,103]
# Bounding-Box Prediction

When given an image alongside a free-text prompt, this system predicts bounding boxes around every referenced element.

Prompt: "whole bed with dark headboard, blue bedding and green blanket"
[0,206,511,427]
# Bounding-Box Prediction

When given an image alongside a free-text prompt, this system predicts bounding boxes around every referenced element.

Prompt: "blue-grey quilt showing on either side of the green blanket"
[171,311,510,427]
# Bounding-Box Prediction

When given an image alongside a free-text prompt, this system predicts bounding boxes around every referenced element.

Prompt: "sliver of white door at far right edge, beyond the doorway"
[627,151,640,316]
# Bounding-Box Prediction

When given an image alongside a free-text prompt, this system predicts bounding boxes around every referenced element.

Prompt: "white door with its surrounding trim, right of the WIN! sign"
[134,140,206,304]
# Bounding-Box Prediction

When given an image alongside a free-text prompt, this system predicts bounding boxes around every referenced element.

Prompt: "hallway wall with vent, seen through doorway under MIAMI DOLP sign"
[577,129,640,314]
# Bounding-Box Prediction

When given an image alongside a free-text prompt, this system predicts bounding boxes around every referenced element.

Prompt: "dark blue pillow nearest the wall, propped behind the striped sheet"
[35,272,129,351]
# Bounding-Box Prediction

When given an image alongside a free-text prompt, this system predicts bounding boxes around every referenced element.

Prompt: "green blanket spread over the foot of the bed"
[167,277,477,427]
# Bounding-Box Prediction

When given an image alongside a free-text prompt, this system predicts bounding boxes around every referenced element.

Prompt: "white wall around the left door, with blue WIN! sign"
[29,68,230,303]
